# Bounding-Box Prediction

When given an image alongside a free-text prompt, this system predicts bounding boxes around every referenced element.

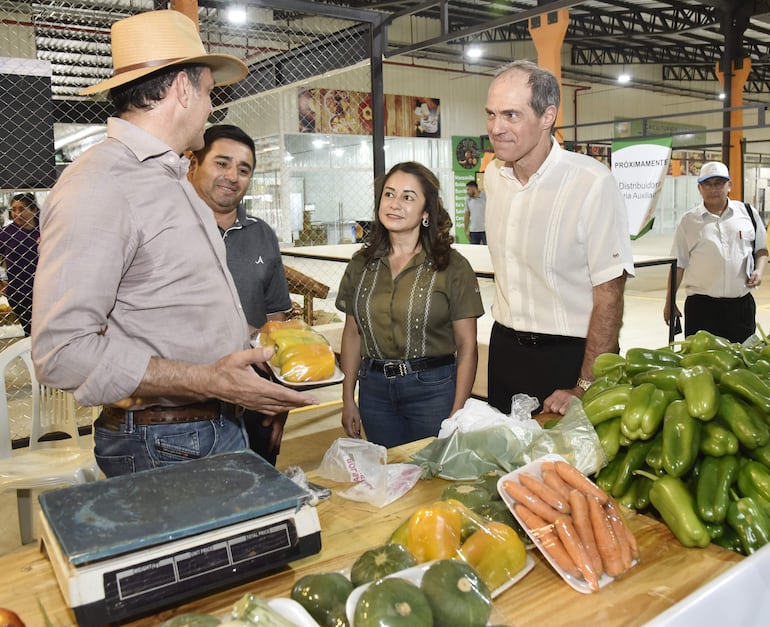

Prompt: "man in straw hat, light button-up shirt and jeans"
[32,11,316,476]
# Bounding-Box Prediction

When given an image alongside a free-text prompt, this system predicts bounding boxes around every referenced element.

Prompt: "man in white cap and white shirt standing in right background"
[663,161,767,342]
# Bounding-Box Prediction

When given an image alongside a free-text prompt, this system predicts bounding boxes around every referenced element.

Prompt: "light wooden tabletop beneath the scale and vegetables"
[0,441,742,627]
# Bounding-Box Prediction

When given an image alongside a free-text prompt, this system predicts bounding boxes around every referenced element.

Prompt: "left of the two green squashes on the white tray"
[353,577,432,627]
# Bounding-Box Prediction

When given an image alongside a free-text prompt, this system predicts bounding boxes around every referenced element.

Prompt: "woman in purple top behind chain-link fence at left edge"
[0,194,40,335]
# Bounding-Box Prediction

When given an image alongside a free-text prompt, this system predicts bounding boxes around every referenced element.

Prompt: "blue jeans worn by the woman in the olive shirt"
[358,360,457,448]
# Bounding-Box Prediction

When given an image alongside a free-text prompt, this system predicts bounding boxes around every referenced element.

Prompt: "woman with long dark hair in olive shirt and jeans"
[336,162,484,447]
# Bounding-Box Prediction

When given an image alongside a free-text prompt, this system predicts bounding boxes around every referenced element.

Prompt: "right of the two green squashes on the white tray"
[420,560,492,627]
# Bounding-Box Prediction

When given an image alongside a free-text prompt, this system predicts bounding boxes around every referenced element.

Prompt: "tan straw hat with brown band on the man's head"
[80,10,248,96]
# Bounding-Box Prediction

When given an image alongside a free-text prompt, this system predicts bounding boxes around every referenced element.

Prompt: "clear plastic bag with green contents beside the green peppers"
[412,398,607,480]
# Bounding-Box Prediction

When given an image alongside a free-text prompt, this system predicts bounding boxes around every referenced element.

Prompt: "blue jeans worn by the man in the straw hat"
[94,417,247,477]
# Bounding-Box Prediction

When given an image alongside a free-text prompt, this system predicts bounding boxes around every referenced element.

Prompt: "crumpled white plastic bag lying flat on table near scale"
[317,438,422,507]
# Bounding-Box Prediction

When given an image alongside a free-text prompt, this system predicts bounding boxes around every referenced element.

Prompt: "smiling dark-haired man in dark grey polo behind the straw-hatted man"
[188,124,291,464]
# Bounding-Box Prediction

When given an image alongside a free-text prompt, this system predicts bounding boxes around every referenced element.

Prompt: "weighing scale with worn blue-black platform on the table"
[40,451,321,627]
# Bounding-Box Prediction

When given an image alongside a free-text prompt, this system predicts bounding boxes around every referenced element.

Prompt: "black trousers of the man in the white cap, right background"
[684,294,757,342]
